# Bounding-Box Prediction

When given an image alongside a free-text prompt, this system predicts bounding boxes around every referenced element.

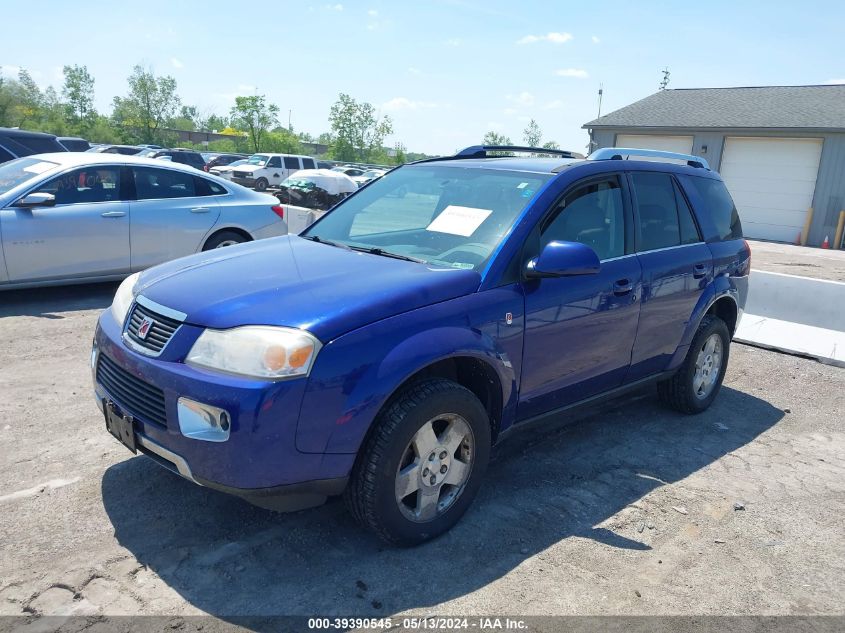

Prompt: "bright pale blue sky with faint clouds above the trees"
[0,0,845,154]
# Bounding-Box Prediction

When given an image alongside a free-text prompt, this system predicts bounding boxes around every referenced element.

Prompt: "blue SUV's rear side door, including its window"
[626,171,713,382]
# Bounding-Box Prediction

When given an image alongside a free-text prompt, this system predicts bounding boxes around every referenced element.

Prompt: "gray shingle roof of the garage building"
[583,85,845,130]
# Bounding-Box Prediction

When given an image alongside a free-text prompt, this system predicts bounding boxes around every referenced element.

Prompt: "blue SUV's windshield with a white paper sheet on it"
[301,165,552,270]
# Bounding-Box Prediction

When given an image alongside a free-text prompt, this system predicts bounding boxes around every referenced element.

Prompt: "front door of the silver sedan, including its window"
[0,165,129,282]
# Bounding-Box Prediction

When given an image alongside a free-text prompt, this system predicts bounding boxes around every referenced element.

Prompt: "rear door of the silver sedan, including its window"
[129,167,220,271]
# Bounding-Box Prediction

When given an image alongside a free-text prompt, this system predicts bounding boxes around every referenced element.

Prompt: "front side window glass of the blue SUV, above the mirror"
[540,177,625,260]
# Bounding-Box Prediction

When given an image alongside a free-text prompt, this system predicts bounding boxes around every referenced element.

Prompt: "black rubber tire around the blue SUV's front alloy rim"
[344,378,491,546]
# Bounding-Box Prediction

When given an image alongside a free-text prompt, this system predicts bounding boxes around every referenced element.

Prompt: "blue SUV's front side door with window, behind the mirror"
[518,175,641,419]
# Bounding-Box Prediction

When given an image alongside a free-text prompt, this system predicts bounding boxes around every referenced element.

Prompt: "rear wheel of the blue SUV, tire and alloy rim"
[657,314,731,413]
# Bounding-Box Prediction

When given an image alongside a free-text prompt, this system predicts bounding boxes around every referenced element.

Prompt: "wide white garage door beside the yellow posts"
[719,136,822,242]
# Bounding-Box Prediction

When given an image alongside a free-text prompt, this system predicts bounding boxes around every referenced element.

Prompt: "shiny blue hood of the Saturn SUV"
[136,235,481,342]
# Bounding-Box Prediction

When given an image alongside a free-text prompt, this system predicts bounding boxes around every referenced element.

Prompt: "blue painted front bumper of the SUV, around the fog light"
[92,310,354,502]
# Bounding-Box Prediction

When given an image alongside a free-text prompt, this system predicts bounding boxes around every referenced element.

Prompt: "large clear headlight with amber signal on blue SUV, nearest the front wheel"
[185,325,321,380]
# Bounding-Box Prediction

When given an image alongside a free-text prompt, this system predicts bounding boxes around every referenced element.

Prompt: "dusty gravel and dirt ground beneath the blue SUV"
[0,282,845,618]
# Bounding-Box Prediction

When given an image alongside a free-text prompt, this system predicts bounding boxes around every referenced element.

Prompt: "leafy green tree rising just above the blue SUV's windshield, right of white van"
[329,93,393,162]
